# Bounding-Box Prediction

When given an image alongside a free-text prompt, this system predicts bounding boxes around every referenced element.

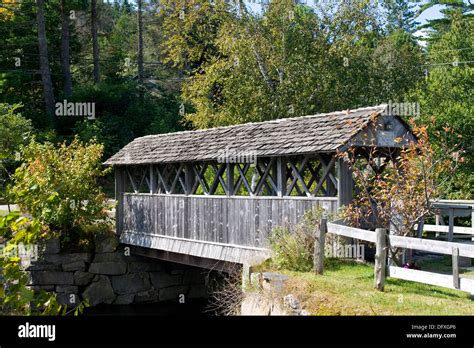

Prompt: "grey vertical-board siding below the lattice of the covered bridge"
[123,193,338,248]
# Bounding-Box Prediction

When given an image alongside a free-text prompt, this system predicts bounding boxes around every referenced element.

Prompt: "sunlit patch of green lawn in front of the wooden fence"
[274,260,474,315]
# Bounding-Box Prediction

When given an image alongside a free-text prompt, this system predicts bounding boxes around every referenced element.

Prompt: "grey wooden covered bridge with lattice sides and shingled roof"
[105,105,413,268]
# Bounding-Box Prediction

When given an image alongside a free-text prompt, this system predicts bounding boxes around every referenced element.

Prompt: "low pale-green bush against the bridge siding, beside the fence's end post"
[270,207,324,272]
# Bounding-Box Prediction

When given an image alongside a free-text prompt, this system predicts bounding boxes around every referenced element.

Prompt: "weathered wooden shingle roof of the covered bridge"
[105,105,396,165]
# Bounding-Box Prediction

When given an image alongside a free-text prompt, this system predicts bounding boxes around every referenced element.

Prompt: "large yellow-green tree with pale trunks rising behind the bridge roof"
[183,0,422,128]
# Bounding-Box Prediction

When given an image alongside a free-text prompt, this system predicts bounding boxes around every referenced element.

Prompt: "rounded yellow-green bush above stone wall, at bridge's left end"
[10,139,106,235]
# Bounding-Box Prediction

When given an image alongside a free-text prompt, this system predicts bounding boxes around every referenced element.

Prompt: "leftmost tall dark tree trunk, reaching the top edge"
[36,0,54,119]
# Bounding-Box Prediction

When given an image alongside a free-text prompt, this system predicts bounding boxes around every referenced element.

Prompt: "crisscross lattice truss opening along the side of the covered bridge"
[124,154,338,197]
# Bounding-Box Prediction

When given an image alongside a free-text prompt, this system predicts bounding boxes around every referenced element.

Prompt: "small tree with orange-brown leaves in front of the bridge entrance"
[340,120,464,263]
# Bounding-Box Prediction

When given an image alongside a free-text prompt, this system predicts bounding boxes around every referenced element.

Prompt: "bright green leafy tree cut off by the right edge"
[417,13,474,199]
